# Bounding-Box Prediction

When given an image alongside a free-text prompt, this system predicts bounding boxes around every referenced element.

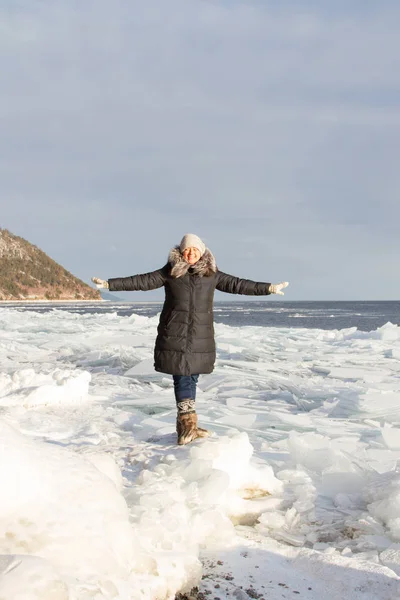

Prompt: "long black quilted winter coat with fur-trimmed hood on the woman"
[108,247,271,375]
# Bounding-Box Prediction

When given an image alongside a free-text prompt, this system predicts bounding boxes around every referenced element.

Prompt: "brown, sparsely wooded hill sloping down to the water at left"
[0,228,101,301]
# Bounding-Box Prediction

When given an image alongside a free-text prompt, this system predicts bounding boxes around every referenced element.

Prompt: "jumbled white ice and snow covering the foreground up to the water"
[0,307,400,600]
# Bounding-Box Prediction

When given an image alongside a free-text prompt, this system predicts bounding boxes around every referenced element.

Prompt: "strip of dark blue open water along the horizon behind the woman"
[0,300,400,331]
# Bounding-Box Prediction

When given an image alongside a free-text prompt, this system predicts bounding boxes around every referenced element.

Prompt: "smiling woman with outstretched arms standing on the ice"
[92,233,288,444]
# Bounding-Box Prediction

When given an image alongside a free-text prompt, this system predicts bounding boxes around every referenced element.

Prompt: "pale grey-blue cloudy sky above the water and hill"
[0,0,400,301]
